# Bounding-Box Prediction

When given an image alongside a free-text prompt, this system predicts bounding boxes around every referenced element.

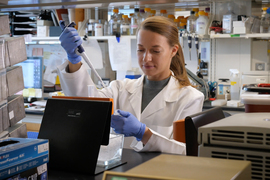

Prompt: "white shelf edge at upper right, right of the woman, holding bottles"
[210,33,270,39]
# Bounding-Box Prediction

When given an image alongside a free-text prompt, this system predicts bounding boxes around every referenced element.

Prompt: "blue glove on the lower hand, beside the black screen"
[111,110,146,141]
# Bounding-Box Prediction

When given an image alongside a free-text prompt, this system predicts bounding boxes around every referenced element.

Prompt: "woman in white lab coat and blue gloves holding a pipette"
[58,16,204,154]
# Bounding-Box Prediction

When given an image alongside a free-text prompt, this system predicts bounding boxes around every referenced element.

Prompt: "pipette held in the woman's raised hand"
[60,21,106,88]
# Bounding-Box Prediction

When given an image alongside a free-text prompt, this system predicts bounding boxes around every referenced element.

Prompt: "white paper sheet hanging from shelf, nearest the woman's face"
[108,36,131,71]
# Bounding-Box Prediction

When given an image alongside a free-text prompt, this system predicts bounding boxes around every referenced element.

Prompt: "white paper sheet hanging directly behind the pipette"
[82,39,103,69]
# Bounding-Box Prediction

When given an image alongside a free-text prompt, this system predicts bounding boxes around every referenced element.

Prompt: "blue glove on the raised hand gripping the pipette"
[59,20,82,64]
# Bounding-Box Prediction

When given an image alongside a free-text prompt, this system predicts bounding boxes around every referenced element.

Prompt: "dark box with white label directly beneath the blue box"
[4,163,48,180]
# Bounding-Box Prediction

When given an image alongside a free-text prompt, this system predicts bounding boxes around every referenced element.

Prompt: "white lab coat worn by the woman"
[58,61,204,154]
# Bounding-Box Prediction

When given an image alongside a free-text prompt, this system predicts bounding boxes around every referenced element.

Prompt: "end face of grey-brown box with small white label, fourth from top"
[8,95,25,126]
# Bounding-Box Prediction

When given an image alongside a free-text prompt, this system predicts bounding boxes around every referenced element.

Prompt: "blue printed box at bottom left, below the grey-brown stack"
[0,138,49,179]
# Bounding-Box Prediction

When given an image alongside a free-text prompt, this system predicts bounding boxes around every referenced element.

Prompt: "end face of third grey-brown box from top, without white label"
[6,66,24,96]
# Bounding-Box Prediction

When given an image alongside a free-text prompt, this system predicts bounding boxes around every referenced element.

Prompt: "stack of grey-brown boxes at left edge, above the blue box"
[0,16,27,138]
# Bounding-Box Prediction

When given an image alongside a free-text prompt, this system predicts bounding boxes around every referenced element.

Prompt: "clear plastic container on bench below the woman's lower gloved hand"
[97,133,124,167]
